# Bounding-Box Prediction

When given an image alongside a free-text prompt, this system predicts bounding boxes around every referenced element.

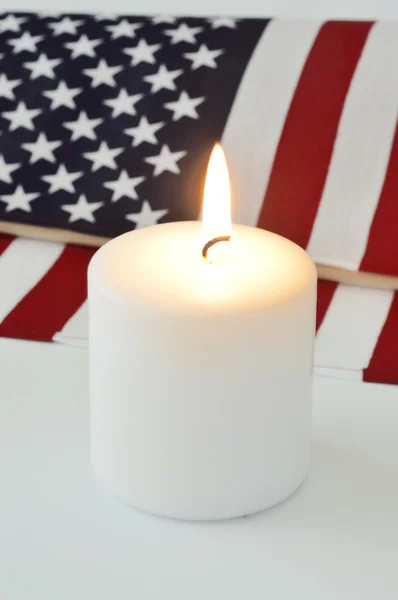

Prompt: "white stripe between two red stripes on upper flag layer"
[307,23,398,271]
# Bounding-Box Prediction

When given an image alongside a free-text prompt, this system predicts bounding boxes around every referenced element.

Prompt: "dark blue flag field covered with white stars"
[0,14,258,242]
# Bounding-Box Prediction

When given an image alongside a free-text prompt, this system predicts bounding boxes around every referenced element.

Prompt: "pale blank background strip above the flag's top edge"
[6,0,398,20]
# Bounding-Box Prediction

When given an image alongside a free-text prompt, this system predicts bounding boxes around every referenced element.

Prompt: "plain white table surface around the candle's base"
[0,339,398,600]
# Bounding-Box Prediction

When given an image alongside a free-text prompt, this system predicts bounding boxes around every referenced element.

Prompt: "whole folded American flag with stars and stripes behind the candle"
[0,13,398,383]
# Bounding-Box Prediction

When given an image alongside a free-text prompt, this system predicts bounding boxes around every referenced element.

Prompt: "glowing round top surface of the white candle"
[89,221,316,313]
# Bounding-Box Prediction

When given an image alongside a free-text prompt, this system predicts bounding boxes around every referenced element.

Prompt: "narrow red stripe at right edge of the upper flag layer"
[360,128,398,275]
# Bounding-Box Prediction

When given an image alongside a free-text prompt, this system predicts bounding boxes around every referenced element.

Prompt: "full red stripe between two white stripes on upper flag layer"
[258,21,372,248]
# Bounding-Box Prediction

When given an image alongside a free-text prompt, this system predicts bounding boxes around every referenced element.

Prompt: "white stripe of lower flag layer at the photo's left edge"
[0,238,65,322]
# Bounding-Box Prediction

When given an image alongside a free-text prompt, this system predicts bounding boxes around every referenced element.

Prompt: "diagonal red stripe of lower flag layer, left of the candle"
[0,245,95,341]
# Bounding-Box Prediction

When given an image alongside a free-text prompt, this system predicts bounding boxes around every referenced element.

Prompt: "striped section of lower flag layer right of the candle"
[315,281,398,384]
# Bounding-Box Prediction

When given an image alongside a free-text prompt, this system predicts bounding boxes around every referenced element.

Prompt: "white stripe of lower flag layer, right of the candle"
[314,285,394,371]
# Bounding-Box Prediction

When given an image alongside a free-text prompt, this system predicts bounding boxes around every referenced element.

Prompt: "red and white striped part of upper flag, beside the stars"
[223,21,398,275]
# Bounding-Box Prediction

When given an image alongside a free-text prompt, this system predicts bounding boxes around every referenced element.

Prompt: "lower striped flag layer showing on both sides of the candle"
[0,230,398,384]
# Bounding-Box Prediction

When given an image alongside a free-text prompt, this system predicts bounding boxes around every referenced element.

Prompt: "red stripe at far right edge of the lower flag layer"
[363,292,398,383]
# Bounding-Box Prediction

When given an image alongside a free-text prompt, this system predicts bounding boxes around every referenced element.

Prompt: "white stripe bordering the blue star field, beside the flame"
[222,20,322,225]
